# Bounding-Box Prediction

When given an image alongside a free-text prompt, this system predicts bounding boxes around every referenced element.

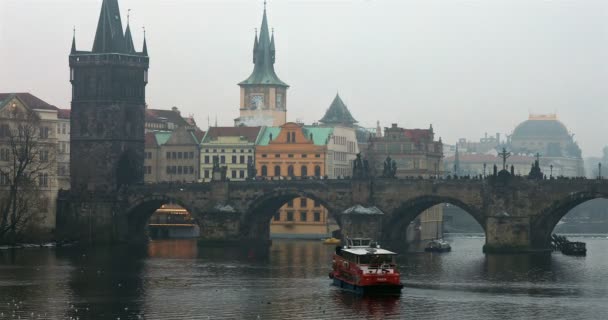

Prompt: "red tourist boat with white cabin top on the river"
[329,238,403,294]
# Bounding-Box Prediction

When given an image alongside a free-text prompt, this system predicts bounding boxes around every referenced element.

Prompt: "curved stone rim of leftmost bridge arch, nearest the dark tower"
[125,194,200,242]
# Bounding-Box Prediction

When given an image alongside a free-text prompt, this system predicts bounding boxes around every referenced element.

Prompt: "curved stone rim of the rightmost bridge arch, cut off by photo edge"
[530,191,608,249]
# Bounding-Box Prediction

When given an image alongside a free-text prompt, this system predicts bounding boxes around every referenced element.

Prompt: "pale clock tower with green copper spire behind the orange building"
[235,4,289,126]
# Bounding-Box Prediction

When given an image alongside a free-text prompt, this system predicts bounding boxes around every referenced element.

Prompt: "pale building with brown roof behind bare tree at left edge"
[0,92,60,241]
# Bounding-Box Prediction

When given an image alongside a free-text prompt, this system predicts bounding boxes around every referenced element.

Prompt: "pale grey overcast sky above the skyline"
[0,0,608,156]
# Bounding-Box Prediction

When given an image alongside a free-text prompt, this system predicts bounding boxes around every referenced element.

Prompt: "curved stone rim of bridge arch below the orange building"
[240,188,341,239]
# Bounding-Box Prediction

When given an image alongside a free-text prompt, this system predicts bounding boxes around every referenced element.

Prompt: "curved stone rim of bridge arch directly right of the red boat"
[380,195,487,241]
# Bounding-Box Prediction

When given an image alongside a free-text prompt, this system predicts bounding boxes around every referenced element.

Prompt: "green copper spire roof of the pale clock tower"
[239,7,289,87]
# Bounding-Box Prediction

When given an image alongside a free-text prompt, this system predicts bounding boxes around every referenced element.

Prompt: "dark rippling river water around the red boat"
[0,235,608,320]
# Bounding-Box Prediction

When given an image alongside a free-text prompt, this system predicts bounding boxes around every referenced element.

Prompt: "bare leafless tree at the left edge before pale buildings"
[0,109,56,243]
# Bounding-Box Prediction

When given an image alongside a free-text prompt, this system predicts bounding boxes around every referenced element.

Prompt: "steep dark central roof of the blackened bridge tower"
[93,0,125,53]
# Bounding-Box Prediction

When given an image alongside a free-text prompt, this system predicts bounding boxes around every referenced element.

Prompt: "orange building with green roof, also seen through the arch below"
[255,122,333,239]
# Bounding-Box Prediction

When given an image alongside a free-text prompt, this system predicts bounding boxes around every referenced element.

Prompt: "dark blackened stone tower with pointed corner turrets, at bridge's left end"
[69,0,149,191]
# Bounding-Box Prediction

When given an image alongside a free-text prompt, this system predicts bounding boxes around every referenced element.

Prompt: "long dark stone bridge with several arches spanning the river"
[57,177,608,252]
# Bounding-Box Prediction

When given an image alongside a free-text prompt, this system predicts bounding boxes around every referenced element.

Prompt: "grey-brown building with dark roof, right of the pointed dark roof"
[367,124,443,241]
